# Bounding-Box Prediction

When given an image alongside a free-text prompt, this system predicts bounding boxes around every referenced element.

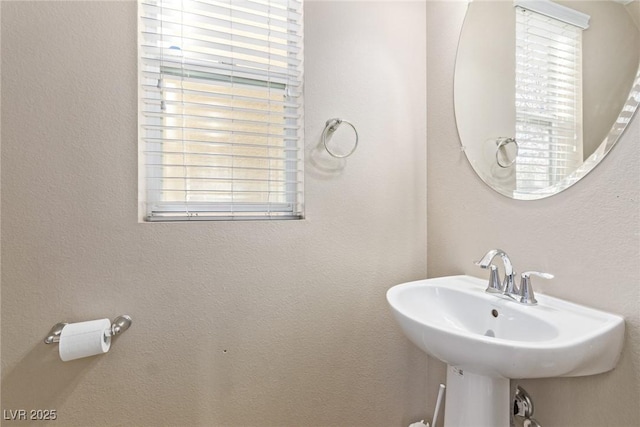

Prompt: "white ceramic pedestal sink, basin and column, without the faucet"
[387,276,624,427]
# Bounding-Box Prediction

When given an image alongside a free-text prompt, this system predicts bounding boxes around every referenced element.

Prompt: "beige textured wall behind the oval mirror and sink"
[427,1,640,427]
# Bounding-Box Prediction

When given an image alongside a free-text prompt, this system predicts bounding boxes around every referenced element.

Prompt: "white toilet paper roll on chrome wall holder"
[59,319,111,362]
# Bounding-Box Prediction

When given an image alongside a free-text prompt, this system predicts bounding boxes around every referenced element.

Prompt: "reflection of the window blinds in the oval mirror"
[515,7,583,191]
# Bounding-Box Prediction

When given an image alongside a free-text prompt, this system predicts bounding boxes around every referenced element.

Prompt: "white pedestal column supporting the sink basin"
[444,366,513,427]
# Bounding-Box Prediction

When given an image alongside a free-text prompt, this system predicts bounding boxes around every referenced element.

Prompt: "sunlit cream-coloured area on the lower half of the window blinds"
[153,77,286,203]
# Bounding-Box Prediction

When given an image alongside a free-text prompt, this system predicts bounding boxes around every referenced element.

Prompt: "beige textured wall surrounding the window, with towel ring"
[2,1,427,427]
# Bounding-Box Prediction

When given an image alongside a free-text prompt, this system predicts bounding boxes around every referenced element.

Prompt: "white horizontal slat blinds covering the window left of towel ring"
[139,0,303,221]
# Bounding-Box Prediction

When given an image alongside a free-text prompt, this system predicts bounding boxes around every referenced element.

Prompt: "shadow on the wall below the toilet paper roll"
[1,342,97,415]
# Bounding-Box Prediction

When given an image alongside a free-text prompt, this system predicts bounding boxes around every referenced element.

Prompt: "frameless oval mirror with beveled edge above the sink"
[454,0,640,200]
